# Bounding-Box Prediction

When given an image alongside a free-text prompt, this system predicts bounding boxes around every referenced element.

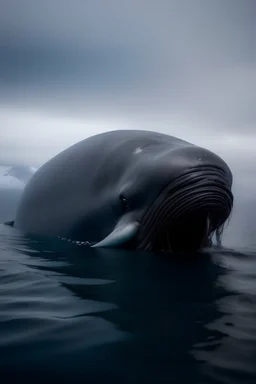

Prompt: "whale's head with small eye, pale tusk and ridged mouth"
[94,144,233,252]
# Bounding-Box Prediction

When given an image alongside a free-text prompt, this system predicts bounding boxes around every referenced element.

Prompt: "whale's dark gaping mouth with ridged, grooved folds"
[138,167,233,252]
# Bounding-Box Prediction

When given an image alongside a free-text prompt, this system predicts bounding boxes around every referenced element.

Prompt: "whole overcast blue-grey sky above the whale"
[0,0,256,191]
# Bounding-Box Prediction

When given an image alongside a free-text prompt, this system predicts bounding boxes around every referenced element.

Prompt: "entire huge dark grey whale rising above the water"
[11,130,233,252]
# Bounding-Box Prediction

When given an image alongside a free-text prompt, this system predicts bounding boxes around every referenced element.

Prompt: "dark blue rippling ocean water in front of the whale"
[0,188,256,384]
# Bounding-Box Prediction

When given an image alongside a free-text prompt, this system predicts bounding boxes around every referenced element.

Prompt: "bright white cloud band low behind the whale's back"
[0,108,256,171]
